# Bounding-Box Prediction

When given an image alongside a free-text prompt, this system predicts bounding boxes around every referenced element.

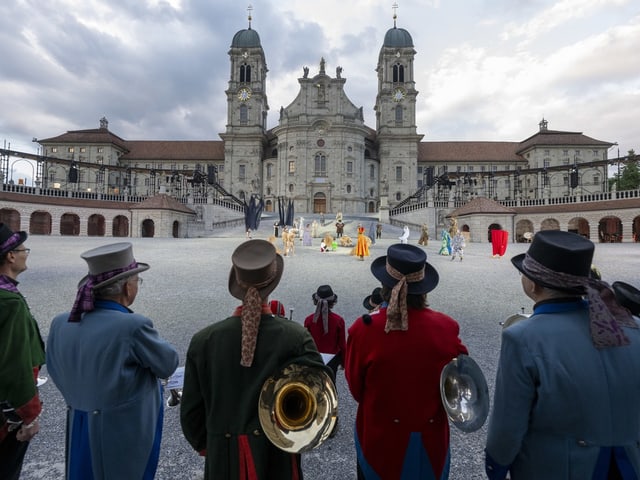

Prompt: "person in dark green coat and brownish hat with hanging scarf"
[180,239,331,480]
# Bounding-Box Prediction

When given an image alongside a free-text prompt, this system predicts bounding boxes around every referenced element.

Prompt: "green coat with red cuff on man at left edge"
[0,289,45,427]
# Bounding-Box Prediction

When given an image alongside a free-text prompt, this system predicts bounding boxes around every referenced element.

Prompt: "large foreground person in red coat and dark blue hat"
[345,244,467,479]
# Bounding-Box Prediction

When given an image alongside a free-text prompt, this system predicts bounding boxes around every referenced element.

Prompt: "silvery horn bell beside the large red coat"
[440,354,489,432]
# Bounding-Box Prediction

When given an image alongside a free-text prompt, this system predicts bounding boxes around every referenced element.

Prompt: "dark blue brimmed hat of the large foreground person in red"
[371,243,440,295]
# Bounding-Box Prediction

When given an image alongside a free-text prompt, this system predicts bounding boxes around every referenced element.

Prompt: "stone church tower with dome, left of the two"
[220,7,269,200]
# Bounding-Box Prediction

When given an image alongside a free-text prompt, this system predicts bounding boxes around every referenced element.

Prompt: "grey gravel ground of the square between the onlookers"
[15,222,640,480]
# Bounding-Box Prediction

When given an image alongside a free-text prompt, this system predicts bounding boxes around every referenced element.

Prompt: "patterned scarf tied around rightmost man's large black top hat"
[522,254,638,348]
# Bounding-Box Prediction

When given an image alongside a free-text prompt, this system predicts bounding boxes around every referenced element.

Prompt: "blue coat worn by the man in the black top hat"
[486,301,640,480]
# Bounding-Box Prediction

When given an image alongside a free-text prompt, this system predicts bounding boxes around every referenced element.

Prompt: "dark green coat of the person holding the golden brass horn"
[180,315,331,480]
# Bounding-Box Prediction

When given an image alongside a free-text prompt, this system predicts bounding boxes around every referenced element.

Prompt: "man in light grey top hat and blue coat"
[47,242,178,480]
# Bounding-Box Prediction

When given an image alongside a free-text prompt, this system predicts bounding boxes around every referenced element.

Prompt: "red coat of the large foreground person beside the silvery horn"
[345,308,467,480]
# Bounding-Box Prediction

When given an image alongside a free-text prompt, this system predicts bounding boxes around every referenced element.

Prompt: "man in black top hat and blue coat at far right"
[486,230,640,480]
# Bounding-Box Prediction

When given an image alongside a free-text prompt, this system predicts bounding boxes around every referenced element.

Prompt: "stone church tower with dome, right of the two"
[374,6,423,207]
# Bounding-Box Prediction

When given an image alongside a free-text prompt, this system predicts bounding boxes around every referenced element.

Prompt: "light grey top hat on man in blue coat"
[78,242,149,290]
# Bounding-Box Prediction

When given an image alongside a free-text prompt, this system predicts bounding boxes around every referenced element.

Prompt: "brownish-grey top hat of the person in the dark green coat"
[229,239,284,300]
